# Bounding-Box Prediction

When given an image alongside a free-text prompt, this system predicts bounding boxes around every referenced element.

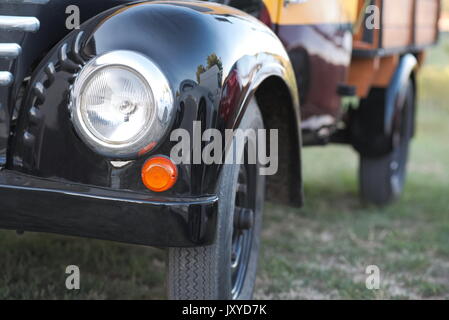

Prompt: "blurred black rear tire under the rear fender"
[359,80,415,206]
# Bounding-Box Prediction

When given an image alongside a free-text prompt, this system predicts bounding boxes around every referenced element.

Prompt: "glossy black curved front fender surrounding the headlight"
[8,2,299,196]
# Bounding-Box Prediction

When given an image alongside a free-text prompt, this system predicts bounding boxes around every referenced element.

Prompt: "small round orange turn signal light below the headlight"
[142,156,178,192]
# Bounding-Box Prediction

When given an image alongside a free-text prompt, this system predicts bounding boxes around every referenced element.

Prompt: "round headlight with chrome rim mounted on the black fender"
[71,51,173,159]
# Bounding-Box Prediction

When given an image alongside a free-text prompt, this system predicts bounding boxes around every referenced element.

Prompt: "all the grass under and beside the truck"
[0,36,449,299]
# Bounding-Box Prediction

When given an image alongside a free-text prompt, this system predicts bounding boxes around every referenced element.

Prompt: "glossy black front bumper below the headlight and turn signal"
[0,170,218,247]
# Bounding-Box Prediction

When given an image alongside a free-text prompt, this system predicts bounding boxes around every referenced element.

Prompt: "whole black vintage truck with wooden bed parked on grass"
[0,0,440,299]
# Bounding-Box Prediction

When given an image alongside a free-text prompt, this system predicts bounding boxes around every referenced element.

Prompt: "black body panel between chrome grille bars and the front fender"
[0,0,138,166]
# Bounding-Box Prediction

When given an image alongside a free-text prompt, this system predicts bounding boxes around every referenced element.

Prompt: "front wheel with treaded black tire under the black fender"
[167,99,265,300]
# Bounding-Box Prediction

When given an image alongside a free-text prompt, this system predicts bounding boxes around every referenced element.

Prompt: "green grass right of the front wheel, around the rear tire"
[257,35,449,299]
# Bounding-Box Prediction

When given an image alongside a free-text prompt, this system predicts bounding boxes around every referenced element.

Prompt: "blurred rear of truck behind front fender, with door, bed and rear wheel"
[260,0,440,205]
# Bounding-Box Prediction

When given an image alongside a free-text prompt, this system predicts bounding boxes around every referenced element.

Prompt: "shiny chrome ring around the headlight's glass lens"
[70,50,174,160]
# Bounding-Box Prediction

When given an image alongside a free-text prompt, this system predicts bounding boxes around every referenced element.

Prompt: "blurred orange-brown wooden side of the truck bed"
[349,0,441,97]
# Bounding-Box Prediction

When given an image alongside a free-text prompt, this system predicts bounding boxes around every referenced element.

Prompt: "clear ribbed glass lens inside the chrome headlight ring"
[80,66,155,145]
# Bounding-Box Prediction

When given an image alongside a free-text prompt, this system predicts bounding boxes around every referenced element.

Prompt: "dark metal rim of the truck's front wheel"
[231,161,255,299]
